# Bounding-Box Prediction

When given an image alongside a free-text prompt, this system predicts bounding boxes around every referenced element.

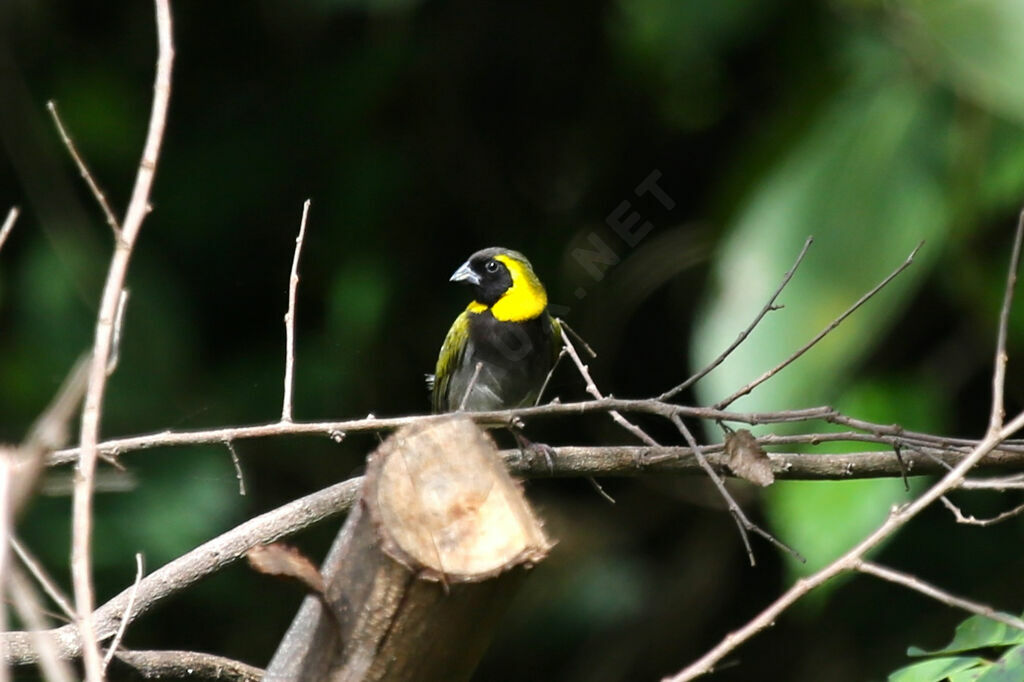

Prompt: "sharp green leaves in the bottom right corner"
[889,615,1024,682]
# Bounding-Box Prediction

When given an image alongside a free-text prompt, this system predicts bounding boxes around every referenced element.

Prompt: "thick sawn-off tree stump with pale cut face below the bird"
[264,416,551,682]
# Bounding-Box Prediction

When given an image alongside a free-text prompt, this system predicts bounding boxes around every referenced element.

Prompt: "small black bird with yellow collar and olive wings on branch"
[427,247,562,412]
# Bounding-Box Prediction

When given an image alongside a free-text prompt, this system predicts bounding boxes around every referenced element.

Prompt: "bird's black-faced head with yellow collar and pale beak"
[452,247,548,322]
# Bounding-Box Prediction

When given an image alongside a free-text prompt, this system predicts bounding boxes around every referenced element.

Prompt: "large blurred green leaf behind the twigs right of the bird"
[692,52,949,589]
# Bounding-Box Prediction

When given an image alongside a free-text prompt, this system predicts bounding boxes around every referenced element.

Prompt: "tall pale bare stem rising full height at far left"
[71,0,174,682]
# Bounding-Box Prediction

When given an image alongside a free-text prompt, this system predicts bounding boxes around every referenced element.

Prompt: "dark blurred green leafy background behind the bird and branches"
[0,0,1024,682]
